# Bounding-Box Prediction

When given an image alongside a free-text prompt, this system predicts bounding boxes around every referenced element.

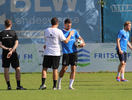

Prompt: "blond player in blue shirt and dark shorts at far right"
[116,21,132,81]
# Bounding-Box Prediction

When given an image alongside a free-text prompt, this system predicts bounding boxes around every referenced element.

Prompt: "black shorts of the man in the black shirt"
[2,52,19,68]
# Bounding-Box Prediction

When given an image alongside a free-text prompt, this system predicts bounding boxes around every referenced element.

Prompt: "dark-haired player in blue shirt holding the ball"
[57,19,85,89]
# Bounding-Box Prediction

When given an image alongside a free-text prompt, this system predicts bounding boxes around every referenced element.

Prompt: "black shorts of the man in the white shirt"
[43,55,60,69]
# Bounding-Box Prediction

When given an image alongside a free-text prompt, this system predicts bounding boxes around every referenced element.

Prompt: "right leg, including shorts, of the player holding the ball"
[69,52,78,89]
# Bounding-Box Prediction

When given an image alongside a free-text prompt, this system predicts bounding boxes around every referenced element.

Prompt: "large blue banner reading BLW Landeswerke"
[0,0,102,44]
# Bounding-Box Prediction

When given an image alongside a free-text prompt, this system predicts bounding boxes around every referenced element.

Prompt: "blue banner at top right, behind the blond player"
[103,0,132,43]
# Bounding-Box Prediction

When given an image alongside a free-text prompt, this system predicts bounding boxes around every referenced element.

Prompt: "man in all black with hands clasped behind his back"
[0,19,25,90]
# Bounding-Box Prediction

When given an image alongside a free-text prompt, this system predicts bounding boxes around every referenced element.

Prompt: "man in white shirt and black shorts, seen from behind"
[39,17,74,90]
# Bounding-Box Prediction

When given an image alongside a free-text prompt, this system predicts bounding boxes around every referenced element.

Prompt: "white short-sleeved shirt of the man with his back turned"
[44,28,66,56]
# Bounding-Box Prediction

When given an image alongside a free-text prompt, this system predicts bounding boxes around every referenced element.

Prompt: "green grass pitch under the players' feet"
[0,72,132,100]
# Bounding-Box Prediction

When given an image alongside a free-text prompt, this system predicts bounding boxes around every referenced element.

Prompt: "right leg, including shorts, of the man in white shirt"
[53,56,60,90]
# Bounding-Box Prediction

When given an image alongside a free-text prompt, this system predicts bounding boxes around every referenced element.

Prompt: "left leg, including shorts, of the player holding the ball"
[57,54,69,89]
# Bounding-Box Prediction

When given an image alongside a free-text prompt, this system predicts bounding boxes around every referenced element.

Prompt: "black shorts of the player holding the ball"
[62,52,78,66]
